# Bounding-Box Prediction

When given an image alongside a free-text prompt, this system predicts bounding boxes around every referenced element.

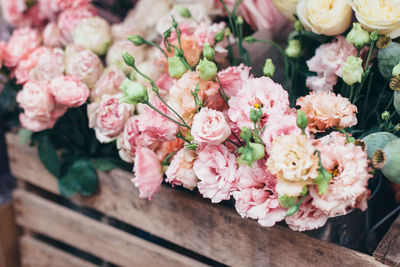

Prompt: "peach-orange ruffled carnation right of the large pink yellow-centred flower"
[296,92,357,133]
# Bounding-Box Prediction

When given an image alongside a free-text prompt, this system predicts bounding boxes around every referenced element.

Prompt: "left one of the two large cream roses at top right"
[297,0,353,36]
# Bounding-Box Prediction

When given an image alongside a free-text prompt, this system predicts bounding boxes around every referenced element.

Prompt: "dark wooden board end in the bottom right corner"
[374,215,400,266]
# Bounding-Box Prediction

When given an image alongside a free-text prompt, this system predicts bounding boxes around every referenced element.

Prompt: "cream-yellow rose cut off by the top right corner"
[349,0,400,39]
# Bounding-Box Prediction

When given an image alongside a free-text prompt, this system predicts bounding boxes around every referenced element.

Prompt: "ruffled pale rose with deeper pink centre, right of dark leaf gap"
[87,94,134,143]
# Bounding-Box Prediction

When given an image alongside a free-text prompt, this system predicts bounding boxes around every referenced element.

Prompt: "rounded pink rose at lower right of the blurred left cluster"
[50,76,90,108]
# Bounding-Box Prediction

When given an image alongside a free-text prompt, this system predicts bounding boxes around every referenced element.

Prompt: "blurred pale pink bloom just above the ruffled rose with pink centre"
[90,66,126,102]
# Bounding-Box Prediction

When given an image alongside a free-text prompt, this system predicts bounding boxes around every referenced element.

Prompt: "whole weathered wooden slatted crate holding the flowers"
[7,134,400,266]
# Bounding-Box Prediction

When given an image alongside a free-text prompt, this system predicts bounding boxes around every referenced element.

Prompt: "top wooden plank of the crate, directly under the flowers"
[7,135,381,266]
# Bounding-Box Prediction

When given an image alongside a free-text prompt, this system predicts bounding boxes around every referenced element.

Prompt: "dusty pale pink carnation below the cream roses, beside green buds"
[306,35,357,92]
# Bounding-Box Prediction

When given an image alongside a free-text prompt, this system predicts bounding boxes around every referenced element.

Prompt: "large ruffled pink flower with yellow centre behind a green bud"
[228,77,289,129]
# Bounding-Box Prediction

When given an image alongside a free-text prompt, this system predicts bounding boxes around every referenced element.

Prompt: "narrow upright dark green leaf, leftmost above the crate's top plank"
[38,136,61,177]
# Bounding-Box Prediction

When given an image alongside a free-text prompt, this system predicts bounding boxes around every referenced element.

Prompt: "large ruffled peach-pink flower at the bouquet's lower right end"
[309,132,372,217]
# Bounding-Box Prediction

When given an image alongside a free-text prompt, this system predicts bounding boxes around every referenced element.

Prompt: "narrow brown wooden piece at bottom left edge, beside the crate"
[0,202,19,266]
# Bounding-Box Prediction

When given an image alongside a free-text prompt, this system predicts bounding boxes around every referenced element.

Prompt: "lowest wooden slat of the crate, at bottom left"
[19,236,95,267]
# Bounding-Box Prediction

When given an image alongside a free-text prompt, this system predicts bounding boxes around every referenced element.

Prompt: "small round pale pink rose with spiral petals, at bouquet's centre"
[191,108,231,145]
